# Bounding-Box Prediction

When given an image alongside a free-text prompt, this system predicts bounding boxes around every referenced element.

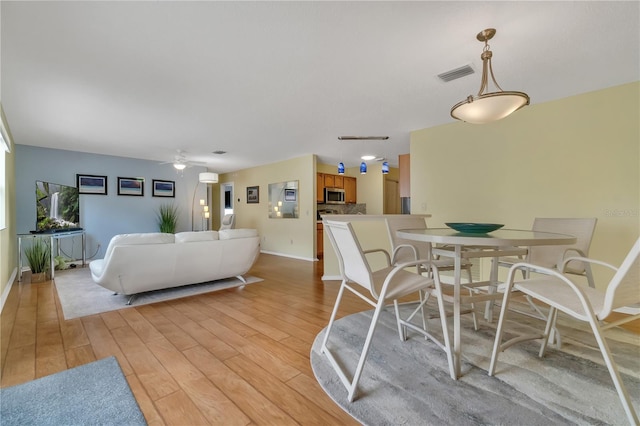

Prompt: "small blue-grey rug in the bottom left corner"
[0,357,147,426]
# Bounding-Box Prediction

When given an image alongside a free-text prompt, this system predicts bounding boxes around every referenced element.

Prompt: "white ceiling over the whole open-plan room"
[0,0,640,173]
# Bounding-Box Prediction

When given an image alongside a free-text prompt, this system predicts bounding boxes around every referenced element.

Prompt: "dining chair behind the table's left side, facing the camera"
[385,215,478,331]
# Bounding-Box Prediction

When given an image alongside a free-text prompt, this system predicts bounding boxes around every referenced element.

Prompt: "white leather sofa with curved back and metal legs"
[89,229,260,303]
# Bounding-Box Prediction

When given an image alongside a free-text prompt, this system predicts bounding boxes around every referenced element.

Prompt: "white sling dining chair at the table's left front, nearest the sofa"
[321,220,452,402]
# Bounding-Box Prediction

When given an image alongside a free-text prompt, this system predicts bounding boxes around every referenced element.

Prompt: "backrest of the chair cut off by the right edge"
[600,238,640,319]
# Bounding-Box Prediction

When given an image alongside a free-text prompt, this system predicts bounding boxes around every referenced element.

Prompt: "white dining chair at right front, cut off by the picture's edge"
[489,238,640,424]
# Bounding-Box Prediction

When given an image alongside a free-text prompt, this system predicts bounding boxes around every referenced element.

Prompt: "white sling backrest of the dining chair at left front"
[323,220,378,299]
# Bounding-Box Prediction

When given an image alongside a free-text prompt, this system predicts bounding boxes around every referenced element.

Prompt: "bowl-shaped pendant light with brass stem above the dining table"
[451,28,529,124]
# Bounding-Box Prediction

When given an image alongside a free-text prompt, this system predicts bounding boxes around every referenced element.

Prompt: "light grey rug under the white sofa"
[55,268,262,320]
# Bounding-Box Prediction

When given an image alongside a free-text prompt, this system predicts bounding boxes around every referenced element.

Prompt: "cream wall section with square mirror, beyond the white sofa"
[219,155,316,260]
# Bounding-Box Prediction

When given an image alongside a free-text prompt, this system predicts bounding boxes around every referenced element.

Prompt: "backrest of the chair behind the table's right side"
[528,217,597,274]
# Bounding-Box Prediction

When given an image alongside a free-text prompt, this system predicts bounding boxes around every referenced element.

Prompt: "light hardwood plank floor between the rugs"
[0,254,640,425]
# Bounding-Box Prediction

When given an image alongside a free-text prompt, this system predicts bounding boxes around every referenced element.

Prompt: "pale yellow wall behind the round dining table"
[411,82,640,288]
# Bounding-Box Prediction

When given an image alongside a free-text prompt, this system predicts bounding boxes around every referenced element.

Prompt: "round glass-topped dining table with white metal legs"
[397,228,576,380]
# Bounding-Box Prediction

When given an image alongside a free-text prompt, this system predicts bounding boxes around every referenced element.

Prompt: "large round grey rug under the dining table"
[311,302,640,425]
